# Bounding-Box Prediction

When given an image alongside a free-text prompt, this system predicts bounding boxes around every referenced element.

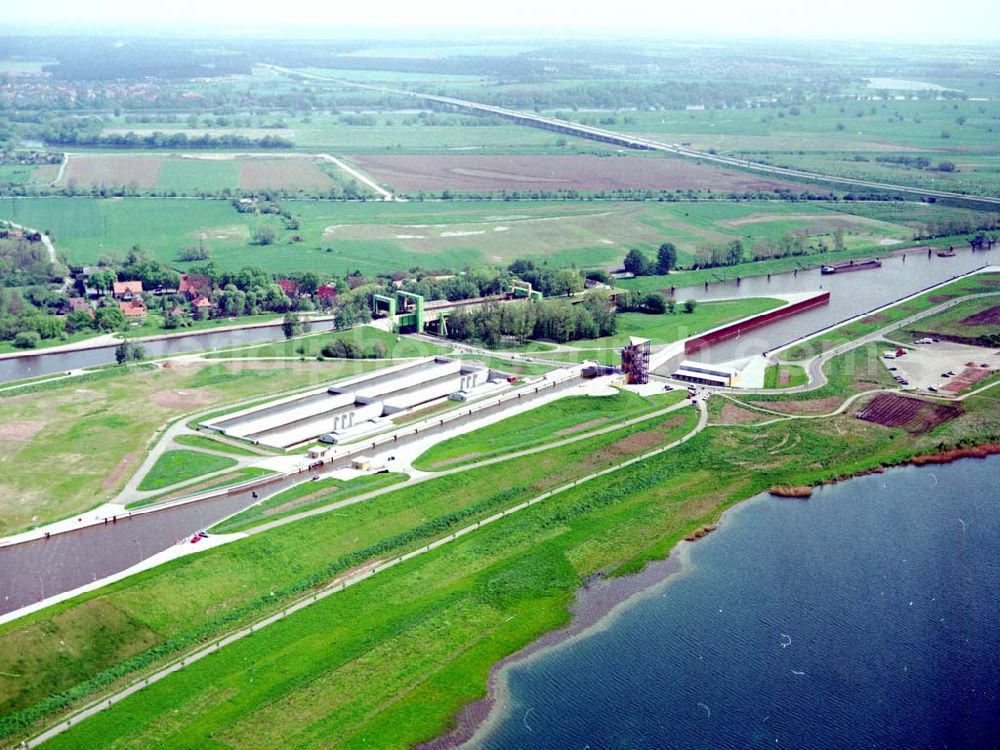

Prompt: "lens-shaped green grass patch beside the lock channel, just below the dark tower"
[413,391,684,471]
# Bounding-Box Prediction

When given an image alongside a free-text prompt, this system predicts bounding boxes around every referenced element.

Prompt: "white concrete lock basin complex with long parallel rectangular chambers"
[203,357,496,449]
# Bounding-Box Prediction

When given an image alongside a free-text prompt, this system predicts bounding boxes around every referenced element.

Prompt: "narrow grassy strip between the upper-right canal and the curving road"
[782,272,1000,361]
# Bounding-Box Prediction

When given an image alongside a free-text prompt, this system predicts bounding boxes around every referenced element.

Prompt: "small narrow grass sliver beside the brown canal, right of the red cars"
[210,472,409,534]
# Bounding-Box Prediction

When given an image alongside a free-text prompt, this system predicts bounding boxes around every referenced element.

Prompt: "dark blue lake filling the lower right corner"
[468,457,1000,750]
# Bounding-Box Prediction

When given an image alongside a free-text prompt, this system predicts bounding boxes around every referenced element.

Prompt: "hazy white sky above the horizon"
[7,0,1000,41]
